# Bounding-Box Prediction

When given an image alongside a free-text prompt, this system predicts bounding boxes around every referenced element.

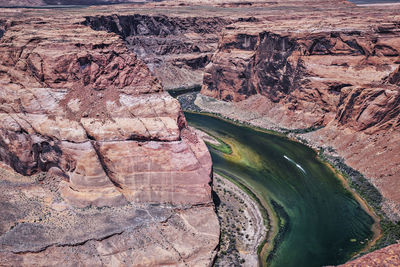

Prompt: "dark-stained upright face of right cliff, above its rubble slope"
[202,24,398,130]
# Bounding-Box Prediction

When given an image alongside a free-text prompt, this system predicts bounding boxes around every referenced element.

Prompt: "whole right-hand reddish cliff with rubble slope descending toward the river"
[201,5,400,218]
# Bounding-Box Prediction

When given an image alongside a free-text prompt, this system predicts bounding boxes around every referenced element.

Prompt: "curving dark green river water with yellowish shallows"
[185,113,374,267]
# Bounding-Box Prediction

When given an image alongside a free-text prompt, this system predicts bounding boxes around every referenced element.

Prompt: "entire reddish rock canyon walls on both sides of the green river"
[0,0,400,266]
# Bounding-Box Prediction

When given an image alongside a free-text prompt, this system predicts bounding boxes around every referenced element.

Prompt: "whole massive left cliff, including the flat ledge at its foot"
[0,9,219,266]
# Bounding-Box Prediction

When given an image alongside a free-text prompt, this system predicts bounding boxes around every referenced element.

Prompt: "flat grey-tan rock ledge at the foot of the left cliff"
[0,163,219,266]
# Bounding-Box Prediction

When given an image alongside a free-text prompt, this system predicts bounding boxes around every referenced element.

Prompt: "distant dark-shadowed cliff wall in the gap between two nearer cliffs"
[85,14,229,89]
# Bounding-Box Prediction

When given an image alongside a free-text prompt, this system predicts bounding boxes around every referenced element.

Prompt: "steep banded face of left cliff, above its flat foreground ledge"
[0,15,216,205]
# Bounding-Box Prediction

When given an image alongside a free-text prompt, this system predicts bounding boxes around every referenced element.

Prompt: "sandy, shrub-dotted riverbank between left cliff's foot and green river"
[214,173,267,266]
